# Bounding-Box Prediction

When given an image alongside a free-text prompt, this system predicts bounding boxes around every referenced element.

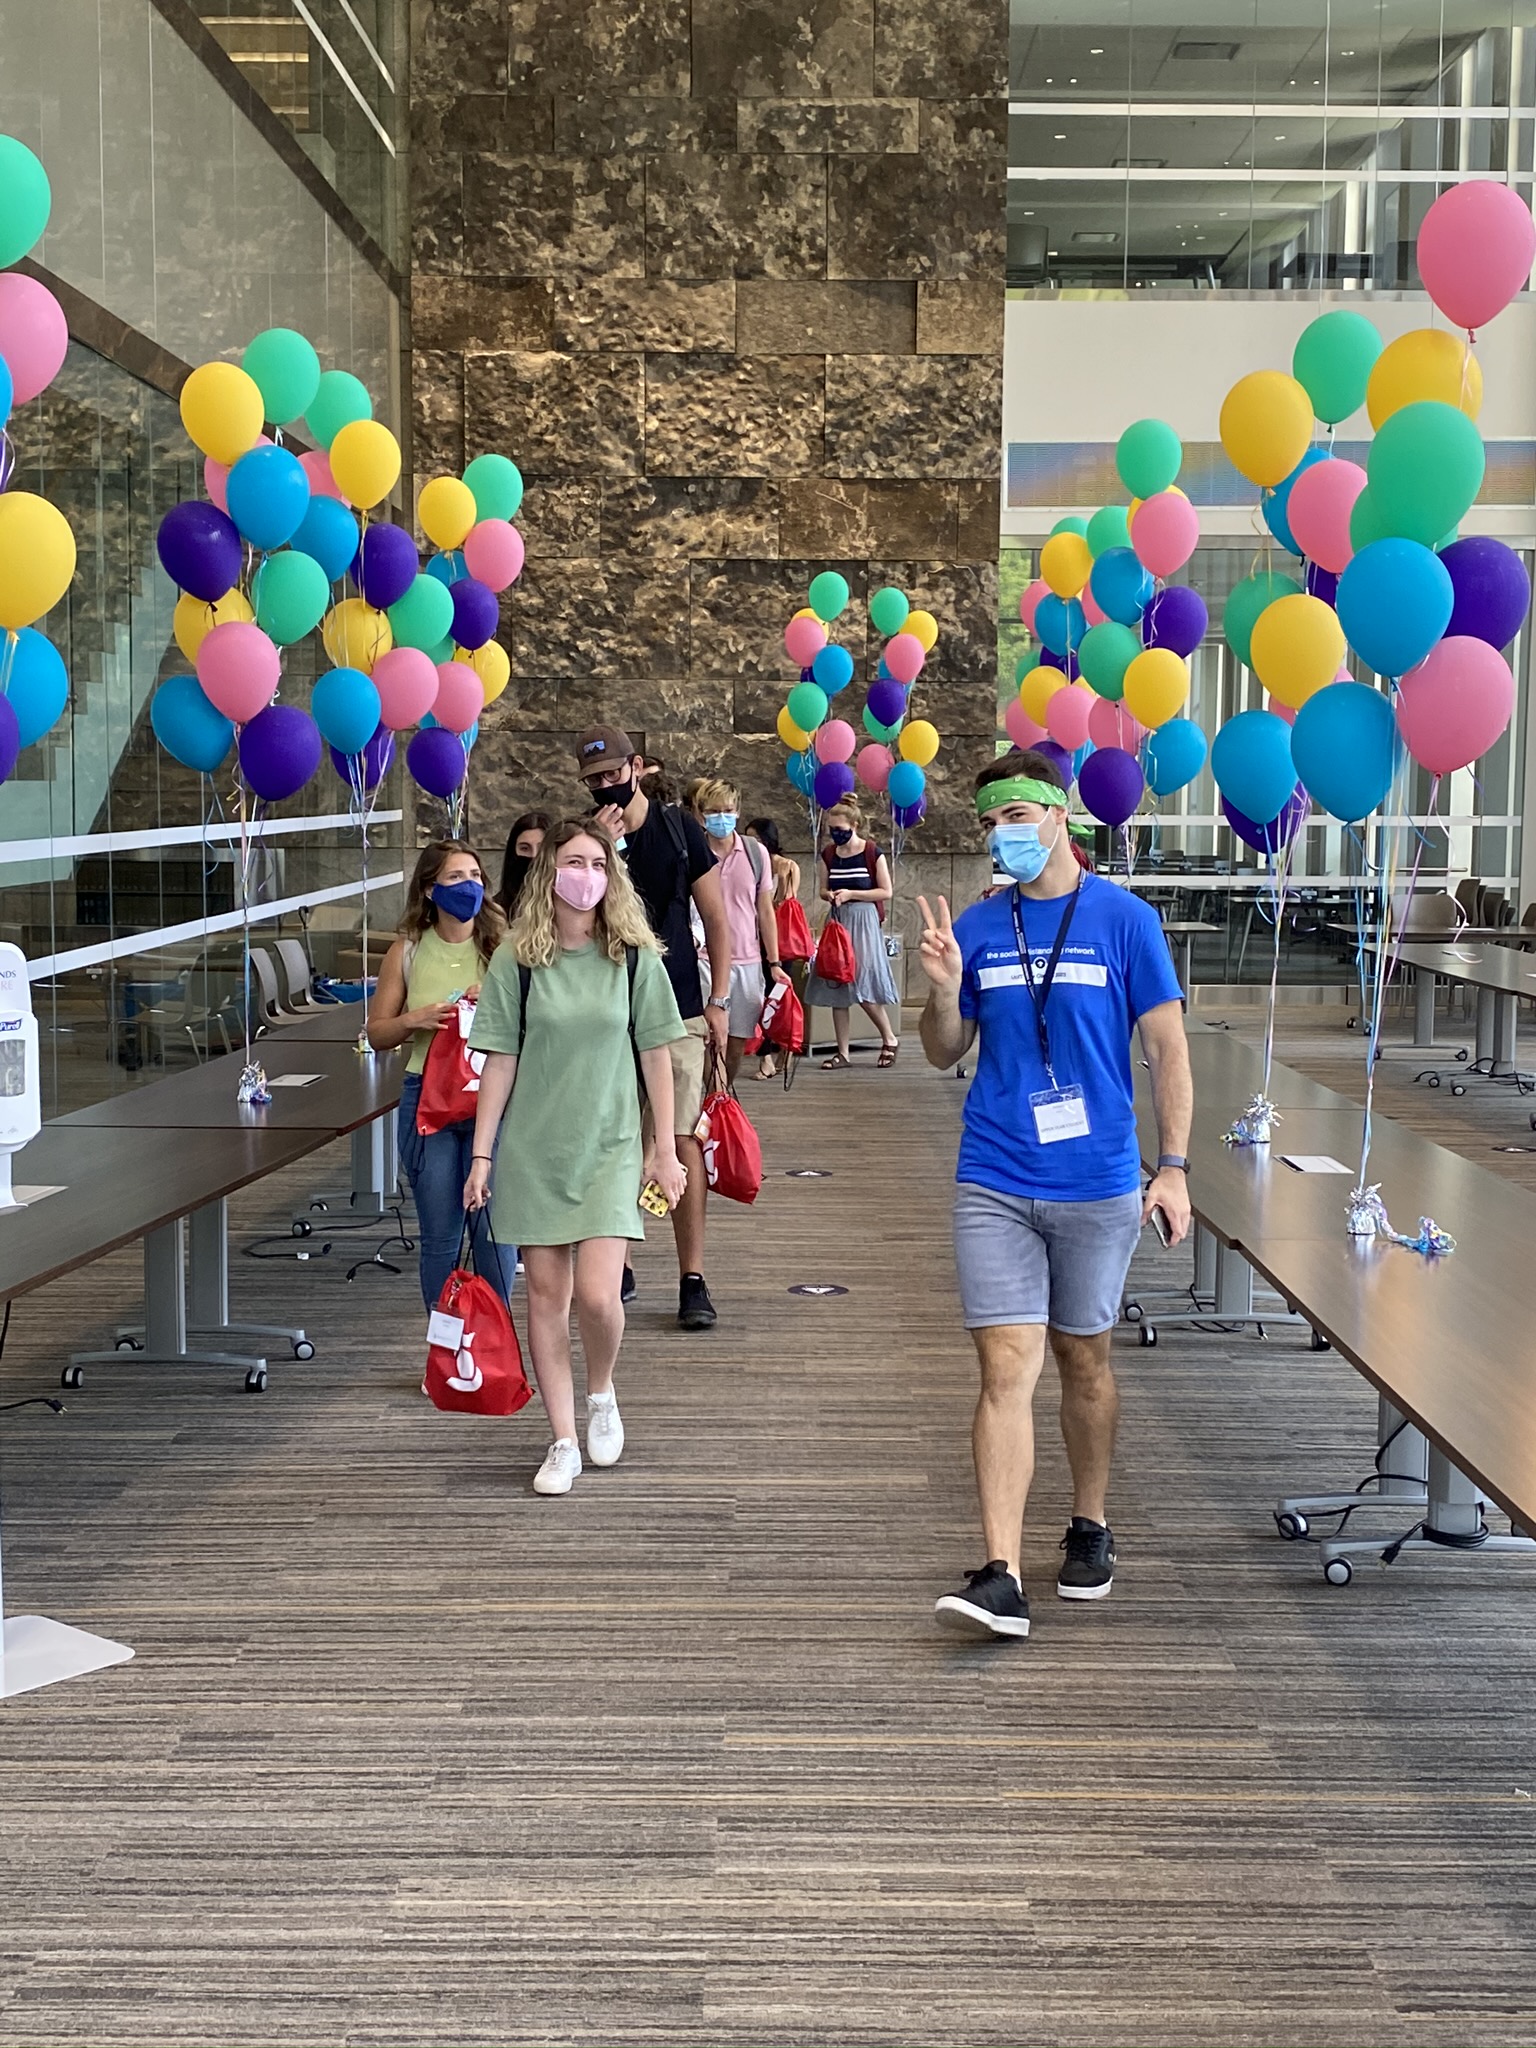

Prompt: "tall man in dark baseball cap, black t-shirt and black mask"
[575,725,731,1329]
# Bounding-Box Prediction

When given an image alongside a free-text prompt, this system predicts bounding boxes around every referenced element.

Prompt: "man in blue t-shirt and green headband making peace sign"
[918,752,1194,1636]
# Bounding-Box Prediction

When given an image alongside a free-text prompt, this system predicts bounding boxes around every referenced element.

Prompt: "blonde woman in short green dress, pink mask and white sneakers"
[465,817,686,1493]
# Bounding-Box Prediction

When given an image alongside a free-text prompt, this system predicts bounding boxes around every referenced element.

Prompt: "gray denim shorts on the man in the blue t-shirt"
[954,1182,1141,1337]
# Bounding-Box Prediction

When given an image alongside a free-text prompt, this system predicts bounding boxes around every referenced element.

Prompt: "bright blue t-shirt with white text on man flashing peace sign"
[954,874,1182,1202]
